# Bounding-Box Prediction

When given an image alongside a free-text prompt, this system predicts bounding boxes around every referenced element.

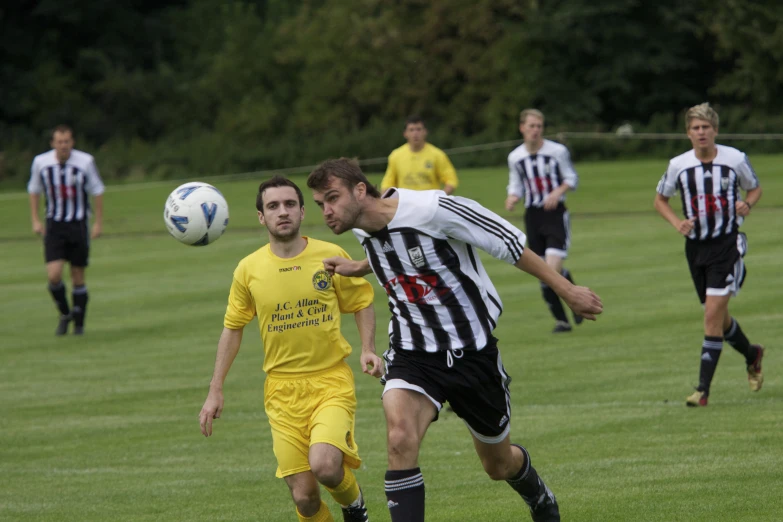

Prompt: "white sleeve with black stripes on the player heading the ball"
[432,194,525,265]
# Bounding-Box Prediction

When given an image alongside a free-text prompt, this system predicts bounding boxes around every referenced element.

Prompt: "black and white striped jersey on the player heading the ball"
[353,188,525,352]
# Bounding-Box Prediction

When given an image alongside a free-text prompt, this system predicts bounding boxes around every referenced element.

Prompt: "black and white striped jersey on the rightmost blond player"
[657,145,759,241]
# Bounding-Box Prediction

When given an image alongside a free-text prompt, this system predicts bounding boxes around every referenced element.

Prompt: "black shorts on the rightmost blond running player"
[685,232,748,304]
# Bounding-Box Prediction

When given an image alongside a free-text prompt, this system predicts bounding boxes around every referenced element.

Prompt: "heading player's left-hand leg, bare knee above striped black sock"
[383,389,438,522]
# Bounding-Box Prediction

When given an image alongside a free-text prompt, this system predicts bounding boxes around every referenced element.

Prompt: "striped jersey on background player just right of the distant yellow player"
[508,140,579,208]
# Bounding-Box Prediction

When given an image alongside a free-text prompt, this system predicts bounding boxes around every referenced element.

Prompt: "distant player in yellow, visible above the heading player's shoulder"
[381,116,459,194]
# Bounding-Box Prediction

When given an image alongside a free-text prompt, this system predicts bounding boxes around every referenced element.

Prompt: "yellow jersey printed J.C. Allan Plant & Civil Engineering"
[223,237,373,376]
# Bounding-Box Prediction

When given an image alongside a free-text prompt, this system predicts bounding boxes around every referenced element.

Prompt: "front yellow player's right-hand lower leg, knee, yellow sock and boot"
[309,442,368,522]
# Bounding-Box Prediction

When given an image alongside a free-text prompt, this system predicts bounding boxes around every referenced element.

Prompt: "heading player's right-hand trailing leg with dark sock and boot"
[473,435,560,522]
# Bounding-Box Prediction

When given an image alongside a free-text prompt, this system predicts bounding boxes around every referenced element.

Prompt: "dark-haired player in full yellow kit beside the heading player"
[199,176,382,522]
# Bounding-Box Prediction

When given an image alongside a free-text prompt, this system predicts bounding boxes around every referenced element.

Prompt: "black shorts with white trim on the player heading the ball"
[382,341,511,444]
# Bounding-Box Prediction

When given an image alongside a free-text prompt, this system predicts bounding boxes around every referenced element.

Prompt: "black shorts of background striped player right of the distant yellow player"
[525,203,571,259]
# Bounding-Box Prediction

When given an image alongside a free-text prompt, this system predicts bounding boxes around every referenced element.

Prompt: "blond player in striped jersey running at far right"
[654,103,764,407]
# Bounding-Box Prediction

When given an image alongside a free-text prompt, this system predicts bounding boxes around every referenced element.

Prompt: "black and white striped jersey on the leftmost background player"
[27,150,104,222]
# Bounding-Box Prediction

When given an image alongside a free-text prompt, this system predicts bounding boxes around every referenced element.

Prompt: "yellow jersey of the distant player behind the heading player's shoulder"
[381,143,458,191]
